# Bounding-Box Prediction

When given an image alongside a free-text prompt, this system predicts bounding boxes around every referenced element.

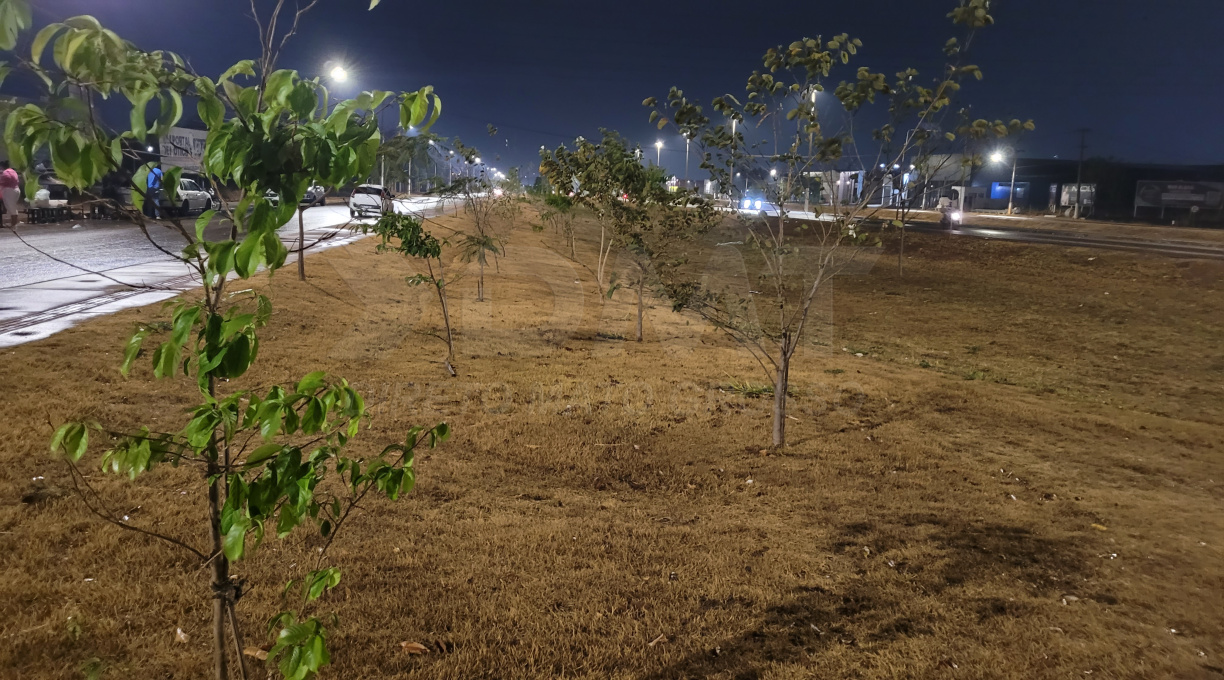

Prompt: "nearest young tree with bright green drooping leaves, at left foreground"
[0,0,449,680]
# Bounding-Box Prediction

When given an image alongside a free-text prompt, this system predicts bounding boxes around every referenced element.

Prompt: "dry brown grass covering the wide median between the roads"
[0,207,1224,680]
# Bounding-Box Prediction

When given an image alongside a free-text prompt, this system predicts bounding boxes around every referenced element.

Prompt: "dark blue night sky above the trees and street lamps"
[28,0,1224,178]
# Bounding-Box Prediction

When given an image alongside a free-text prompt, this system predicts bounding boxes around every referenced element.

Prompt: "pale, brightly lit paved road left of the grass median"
[0,198,450,347]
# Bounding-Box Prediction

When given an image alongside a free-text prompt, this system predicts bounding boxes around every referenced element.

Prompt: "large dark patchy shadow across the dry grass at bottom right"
[643,516,1089,680]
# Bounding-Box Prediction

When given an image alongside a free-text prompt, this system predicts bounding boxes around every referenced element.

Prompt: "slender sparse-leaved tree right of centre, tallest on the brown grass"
[644,0,1023,446]
